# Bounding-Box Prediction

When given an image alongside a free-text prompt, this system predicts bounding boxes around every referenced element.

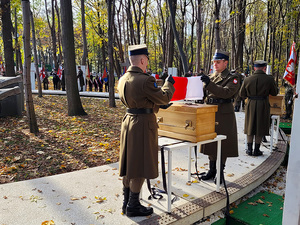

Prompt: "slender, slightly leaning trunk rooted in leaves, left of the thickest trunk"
[22,0,39,134]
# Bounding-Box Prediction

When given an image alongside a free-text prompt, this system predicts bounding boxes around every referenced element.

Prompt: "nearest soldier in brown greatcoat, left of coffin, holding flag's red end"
[118,44,175,217]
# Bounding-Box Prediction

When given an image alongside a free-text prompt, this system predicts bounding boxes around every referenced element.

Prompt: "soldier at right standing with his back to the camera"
[239,60,278,156]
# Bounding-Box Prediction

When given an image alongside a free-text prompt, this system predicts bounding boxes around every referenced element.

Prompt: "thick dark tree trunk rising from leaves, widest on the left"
[60,0,86,116]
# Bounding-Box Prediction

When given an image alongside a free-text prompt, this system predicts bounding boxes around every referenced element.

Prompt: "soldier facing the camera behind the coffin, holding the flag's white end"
[201,49,240,181]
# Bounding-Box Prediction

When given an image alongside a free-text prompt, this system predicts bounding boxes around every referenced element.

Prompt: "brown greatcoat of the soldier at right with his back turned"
[239,70,277,136]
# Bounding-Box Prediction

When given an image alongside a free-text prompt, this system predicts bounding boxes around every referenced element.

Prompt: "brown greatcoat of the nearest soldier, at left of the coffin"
[118,66,175,179]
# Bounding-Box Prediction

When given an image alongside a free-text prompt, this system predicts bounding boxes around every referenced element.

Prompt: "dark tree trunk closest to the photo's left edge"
[1,0,15,77]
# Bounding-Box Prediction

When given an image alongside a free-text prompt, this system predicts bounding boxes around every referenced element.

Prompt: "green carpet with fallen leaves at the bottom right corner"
[213,192,284,225]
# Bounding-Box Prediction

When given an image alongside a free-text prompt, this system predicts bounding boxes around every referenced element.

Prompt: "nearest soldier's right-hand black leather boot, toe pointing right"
[126,191,153,217]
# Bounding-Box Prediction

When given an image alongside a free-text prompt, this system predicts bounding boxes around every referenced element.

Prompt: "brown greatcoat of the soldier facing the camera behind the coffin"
[201,69,240,160]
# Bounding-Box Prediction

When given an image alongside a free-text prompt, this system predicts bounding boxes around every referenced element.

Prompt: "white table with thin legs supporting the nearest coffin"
[158,135,227,212]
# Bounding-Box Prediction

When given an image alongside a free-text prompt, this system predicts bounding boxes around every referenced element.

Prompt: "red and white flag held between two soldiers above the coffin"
[171,77,203,101]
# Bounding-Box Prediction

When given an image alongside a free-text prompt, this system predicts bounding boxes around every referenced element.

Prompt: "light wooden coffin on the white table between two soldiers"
[157,103,218,143]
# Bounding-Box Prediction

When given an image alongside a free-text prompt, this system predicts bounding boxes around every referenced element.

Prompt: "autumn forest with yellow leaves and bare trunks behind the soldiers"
[0,0,300,82]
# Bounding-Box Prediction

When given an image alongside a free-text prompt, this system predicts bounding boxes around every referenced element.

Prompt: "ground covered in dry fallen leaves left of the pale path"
[0,96,125,183]
